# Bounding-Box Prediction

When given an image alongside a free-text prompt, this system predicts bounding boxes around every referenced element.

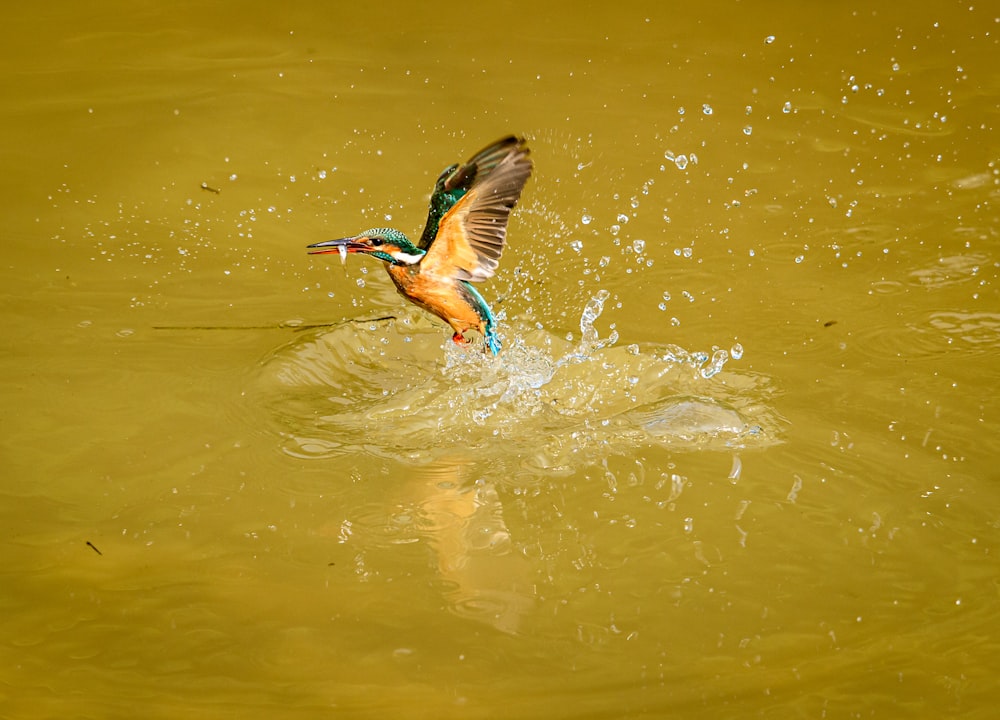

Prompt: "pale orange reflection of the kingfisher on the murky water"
[415,458,534,633]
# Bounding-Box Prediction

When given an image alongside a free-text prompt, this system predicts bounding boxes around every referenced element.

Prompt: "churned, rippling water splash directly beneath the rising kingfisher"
[258,290,776,472]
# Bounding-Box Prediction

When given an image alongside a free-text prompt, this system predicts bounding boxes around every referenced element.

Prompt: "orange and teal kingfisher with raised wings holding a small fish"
[308,135,532,355]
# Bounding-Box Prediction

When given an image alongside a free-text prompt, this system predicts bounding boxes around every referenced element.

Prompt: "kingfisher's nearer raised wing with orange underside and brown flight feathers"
[420,138,531,282]
